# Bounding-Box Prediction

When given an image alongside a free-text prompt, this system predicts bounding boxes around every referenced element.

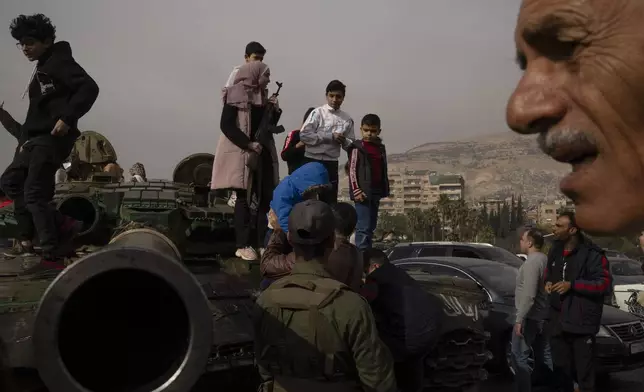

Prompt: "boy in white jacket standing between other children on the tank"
[300,80,355,204]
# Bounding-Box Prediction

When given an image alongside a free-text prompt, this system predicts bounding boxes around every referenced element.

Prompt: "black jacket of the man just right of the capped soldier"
[361,263,443,361]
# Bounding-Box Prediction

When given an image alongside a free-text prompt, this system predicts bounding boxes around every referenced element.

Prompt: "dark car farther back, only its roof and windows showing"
[387,242,523,268]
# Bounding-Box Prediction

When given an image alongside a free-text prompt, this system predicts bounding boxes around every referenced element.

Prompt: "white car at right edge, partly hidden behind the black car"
[609,257,644,318]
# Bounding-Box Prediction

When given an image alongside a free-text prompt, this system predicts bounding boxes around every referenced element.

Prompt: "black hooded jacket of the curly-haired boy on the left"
[19,41,98,159]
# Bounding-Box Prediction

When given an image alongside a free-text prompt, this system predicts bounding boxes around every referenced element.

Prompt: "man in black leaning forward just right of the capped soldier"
[361,249,443,392]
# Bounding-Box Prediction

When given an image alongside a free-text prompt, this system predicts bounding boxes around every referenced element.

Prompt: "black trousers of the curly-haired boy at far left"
[0,145,61,255]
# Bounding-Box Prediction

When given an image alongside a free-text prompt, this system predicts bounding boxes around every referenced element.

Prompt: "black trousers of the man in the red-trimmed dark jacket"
[550,332,595,392]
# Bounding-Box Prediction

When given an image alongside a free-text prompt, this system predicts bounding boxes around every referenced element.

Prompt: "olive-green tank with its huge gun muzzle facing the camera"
[0,136,258,391]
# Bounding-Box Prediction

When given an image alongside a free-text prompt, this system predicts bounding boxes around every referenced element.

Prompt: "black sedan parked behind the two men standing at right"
[394,257,644,374]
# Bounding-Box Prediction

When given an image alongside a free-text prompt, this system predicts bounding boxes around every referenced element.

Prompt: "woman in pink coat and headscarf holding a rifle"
[211,61,281,261]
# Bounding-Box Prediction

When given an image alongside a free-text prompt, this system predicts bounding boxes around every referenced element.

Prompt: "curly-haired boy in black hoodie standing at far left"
[0,14,98,272]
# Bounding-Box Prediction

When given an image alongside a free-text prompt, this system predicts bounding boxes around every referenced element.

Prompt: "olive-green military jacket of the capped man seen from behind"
[254,261,397,392]
